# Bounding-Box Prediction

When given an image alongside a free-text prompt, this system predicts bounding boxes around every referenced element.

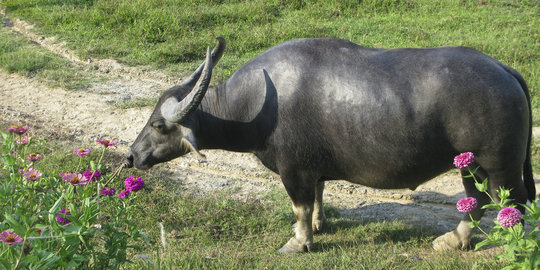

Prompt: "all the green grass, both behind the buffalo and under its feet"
[0,0,540,269]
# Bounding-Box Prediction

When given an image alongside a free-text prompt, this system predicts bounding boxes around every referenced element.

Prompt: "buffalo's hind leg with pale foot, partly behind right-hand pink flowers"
[433,167,490,251]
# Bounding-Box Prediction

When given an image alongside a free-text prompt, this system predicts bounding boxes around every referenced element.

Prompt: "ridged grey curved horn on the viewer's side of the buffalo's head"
[161,48,212,123]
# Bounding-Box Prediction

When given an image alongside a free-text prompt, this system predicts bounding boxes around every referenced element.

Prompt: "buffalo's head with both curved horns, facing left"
[126,37,225,169]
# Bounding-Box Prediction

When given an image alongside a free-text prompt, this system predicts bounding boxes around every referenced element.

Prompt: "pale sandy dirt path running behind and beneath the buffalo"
[0,13,540,236]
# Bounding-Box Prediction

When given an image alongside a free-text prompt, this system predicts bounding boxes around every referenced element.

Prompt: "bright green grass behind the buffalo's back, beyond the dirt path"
[2,0,540,116]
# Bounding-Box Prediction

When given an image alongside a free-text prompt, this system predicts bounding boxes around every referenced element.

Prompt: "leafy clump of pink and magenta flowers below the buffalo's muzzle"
[0,129,148,269]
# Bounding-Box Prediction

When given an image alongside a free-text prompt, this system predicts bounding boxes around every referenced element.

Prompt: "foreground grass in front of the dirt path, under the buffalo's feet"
[0,121,506,269]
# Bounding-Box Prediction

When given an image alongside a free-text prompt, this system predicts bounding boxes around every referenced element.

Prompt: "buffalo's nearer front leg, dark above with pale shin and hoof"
[279,170,316,254]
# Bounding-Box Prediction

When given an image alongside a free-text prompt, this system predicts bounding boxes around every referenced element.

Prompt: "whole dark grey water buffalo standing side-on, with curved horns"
[126,37,535,253]
